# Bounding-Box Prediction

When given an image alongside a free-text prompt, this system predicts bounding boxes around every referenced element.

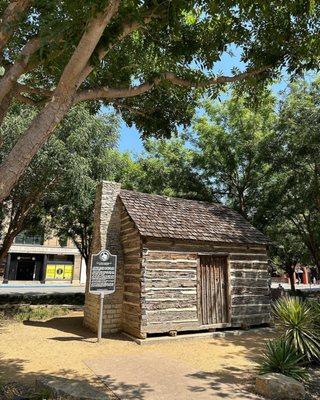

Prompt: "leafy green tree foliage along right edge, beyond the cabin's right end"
[258,78,320,271]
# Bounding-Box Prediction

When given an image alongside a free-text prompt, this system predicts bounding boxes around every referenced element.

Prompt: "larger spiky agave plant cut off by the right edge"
[273,297,320,361]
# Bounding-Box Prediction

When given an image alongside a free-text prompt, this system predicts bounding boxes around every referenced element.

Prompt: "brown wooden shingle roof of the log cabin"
[120,190,269,244]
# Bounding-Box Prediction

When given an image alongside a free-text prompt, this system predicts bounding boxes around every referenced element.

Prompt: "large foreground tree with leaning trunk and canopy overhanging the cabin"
[0,0,320,202]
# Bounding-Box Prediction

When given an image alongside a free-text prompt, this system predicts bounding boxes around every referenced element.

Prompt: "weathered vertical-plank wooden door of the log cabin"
[198,255,229,325]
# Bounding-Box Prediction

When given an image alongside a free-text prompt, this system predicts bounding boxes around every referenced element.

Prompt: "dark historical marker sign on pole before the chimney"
[89,250,117,342]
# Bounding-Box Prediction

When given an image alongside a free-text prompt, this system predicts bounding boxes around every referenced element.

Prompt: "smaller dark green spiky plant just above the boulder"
[258,338,309,381]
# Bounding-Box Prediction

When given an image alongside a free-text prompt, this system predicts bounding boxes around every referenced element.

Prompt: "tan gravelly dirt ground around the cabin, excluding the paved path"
[0,312,271,398]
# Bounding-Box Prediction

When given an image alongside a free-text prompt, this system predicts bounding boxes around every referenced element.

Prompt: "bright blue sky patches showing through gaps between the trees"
[119,48,288,154]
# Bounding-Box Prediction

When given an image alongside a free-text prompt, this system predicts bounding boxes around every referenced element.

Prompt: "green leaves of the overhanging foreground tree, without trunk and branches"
[0,0,320,136]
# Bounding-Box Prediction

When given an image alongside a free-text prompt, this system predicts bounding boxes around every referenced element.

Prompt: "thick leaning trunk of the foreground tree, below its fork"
[0,96,73,203]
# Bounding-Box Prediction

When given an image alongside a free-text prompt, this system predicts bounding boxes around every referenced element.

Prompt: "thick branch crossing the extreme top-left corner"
[0,0,32,53]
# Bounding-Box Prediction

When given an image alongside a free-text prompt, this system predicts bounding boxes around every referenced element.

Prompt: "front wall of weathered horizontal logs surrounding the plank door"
[141,238,270,333]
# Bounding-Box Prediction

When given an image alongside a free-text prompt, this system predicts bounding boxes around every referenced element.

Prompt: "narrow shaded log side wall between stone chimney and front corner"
[121,206,144,338]
